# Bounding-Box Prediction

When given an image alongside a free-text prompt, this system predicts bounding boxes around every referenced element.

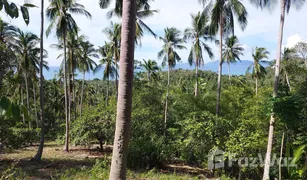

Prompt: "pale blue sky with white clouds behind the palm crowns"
[0,0,307,66]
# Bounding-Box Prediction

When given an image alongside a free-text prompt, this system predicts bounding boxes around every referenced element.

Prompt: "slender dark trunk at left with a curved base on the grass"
[33,0,45,161]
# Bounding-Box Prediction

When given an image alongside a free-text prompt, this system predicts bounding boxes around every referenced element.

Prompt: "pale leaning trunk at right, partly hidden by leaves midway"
[263,0,285,180]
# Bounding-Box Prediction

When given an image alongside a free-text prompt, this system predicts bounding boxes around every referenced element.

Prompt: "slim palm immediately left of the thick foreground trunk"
[103,22,121,97]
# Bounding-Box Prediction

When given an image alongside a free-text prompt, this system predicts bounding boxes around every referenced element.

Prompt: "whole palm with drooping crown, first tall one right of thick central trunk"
[158,28,186,133]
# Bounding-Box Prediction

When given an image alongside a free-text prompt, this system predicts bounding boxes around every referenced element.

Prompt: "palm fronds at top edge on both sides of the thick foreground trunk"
[99,0,158,43]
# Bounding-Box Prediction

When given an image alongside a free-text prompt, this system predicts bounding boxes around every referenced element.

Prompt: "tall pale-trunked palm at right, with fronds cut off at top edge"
[250,0,305,180]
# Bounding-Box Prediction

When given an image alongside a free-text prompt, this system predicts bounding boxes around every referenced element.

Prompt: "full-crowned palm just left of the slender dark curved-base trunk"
[12,28,40,128]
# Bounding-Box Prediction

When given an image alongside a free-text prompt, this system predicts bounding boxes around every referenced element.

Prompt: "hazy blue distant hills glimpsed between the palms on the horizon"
[44,60,268,79]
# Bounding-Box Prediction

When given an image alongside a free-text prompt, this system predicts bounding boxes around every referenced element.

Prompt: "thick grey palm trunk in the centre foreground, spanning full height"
[109,0,136,180]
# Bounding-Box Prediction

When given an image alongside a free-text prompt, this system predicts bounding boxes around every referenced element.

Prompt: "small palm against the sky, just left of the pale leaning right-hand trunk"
[247,47,270,95]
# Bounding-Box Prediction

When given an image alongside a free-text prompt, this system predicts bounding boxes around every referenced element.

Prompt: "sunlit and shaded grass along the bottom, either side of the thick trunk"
[0,142,205,180]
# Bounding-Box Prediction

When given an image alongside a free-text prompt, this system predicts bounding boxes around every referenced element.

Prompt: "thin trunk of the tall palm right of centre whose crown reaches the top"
[216,20,223,116]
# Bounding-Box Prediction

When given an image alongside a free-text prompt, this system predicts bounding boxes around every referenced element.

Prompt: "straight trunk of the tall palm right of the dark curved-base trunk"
[63,29,69,152]
